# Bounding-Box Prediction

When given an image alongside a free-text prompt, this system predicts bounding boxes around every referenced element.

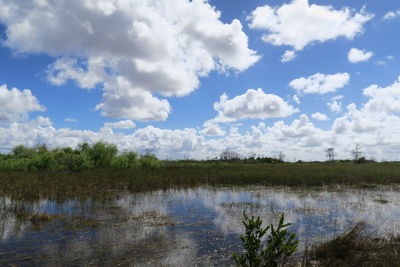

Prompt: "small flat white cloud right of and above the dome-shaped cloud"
[289,73,350,95]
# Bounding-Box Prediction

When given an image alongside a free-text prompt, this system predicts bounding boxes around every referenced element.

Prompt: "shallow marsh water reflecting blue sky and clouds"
[0,186,400,266]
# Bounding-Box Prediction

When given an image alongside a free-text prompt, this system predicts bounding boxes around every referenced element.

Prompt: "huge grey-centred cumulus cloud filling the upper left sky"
[0,0,260,120]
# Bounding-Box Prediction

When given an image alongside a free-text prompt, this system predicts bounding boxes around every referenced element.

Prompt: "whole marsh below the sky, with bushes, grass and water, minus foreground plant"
[0,142,400,266]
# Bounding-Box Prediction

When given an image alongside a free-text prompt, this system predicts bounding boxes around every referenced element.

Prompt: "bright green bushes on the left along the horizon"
[0,142,162,171]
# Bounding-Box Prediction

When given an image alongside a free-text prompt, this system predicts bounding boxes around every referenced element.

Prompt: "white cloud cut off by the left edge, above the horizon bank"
[0,84,46,123]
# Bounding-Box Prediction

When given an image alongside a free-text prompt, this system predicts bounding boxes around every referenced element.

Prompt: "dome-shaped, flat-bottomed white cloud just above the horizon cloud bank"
[214,89,298,122]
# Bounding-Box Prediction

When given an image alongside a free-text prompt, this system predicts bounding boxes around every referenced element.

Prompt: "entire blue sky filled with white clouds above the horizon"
[0,0,400,161]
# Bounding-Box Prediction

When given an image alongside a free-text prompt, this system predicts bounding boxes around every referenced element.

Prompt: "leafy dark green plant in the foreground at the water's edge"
[232,211,299,267]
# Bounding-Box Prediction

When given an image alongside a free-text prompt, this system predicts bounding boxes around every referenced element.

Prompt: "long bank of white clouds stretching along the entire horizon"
[0,77,400,160]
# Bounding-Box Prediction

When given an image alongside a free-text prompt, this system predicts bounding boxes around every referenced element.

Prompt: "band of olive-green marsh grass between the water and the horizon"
[0,162,400,200]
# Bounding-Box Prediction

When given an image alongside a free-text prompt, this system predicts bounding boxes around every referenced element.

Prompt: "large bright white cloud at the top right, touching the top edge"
[248,0,373,50]
